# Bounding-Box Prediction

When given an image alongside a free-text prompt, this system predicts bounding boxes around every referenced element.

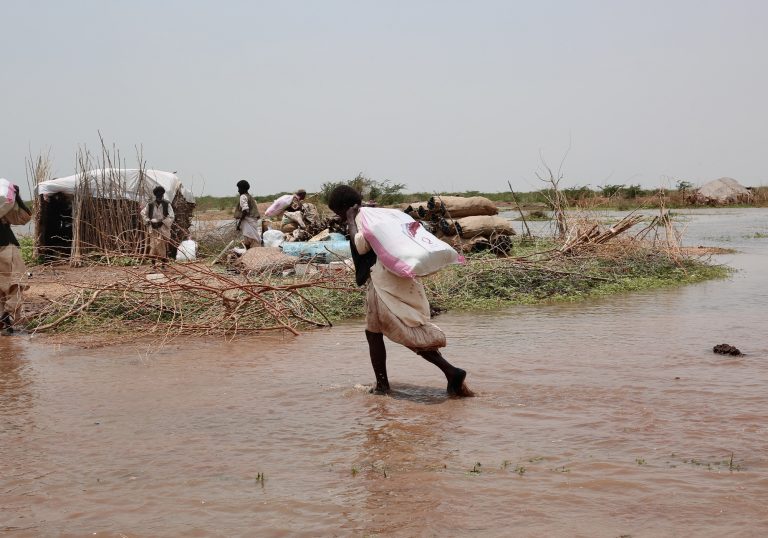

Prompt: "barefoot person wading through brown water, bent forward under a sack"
[328,185,474,396]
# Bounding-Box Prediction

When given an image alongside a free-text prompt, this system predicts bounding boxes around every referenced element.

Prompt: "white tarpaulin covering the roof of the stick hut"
[37,168,195,202]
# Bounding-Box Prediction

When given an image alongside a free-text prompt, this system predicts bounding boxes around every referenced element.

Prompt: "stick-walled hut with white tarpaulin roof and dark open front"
[35,168,195,264]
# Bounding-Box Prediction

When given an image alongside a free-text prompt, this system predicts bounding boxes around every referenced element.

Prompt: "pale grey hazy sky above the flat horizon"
[0,0,768,195]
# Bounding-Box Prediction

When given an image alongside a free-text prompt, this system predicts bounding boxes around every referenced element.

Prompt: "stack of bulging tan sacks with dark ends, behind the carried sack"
[405,196,515,252]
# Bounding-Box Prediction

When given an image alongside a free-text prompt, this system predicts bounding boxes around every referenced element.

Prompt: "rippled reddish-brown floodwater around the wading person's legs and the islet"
[0,209,768,537]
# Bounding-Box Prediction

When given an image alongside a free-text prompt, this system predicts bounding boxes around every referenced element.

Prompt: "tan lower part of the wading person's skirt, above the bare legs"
[365,282,445,351]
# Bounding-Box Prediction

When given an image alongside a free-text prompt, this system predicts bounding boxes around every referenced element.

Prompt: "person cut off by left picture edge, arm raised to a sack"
[0,186,32,335]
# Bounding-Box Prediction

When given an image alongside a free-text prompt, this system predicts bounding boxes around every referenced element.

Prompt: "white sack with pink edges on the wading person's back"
[360,207,464,278]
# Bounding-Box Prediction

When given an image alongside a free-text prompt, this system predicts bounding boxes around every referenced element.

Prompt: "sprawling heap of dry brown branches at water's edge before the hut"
[30,263,356,336]
